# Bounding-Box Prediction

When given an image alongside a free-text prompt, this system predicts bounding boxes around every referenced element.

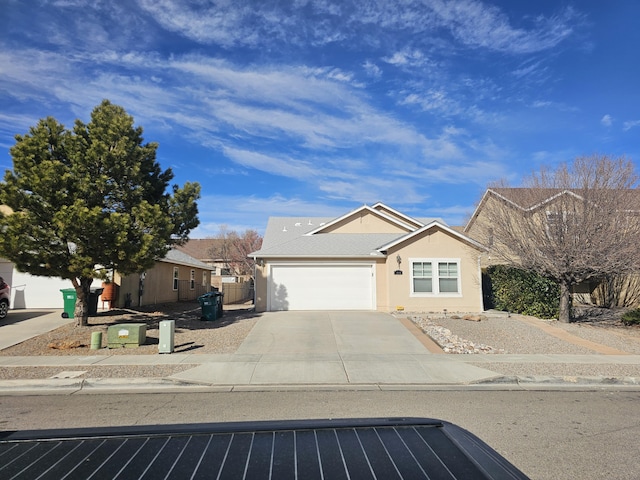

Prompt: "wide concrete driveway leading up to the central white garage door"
[172,311,497,386]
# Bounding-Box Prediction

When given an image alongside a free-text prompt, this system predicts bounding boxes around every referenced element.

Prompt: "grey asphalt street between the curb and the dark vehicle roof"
[0,390,640,480]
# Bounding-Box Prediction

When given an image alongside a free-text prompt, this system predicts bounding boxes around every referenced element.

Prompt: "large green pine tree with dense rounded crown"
[0,100,200,325]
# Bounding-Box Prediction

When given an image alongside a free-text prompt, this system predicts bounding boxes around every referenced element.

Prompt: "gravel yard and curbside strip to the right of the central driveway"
[408,309,640,378]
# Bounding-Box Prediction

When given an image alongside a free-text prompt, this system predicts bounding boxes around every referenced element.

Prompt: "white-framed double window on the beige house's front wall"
[410,258,460,297]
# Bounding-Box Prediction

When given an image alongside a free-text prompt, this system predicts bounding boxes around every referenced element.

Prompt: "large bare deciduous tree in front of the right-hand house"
[472,155,640,322]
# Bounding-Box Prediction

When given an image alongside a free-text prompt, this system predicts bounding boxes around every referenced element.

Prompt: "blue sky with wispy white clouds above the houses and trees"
[0,0,640,238]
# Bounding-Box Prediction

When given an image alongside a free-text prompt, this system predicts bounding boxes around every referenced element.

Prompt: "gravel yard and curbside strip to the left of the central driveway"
[0,303,259,380]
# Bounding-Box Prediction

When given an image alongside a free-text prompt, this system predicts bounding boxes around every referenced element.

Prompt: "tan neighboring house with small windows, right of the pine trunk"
[112,248,212,307]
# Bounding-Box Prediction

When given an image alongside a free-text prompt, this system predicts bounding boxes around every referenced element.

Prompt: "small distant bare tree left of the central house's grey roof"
[209,226,262,278]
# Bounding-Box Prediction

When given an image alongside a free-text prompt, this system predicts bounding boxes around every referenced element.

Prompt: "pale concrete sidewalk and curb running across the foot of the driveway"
[0,354,640,394]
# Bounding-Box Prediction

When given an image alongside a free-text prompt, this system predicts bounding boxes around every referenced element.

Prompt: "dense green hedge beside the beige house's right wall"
[483,265,560,318]
